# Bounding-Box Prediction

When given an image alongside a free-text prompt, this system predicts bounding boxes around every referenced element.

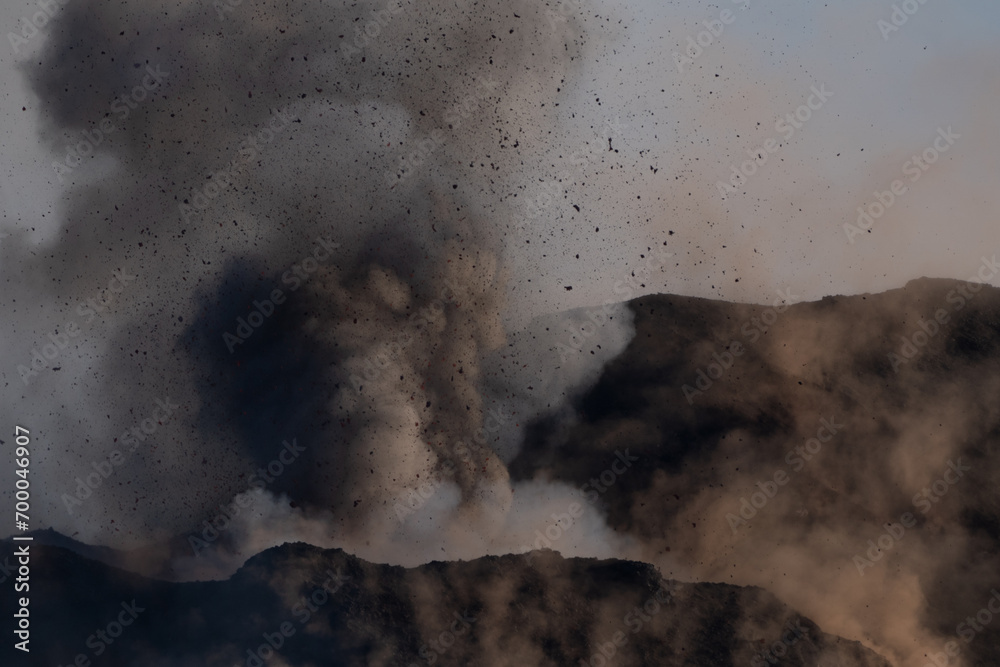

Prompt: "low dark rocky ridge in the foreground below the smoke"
[3,544,887,667]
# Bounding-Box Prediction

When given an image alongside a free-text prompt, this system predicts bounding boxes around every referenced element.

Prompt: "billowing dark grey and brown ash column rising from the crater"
[4,2,644,578]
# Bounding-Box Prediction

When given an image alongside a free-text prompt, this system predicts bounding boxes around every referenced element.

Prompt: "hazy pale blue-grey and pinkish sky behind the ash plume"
[0,0,1000,310]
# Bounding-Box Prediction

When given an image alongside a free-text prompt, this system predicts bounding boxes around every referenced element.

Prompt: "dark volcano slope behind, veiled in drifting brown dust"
[511,279,1000,666]
